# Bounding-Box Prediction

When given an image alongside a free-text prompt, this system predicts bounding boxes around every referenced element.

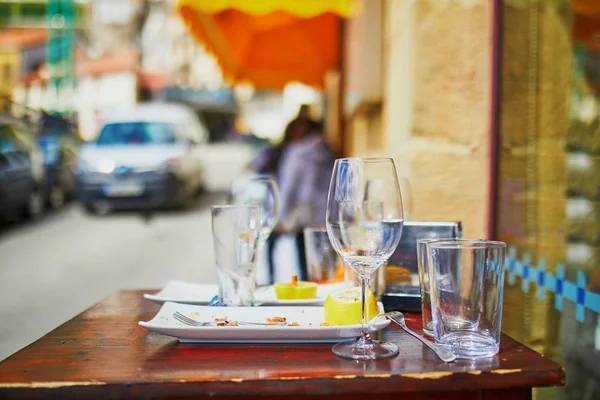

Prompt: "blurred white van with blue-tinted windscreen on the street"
[76,103,208,211]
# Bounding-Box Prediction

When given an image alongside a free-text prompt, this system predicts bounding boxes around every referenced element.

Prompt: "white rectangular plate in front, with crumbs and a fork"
[139,302,390,343]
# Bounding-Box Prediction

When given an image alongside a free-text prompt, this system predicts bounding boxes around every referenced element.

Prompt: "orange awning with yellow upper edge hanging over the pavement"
[178,0,355,89]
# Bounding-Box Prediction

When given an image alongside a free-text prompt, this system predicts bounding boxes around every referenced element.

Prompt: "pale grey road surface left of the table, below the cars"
[0,194,224,360]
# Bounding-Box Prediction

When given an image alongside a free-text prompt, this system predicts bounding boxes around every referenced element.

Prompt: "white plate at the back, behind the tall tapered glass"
[144,281,345,306]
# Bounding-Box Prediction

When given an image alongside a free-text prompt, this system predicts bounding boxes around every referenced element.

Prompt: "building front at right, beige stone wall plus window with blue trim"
[342,0,600,399]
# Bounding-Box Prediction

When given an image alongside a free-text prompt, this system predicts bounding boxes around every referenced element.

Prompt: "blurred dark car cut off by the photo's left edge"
[0,116,44,220]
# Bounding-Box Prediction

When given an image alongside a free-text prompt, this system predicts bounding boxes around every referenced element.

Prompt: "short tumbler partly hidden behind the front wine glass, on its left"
[304,227,349,283]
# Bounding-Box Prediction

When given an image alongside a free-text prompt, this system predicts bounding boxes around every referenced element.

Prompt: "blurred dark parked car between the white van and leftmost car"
[37,114,80,209]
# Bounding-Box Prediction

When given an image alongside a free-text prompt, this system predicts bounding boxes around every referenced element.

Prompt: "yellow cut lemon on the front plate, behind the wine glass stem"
[324,287,379,325]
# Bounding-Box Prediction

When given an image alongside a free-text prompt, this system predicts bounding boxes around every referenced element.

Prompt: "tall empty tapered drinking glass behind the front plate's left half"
[211,205,261,306]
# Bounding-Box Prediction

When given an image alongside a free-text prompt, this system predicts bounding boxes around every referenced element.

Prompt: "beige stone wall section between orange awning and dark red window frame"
[344,0,492,237]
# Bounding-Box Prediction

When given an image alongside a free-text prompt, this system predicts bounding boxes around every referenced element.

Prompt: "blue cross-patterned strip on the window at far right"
[506,247,600,322]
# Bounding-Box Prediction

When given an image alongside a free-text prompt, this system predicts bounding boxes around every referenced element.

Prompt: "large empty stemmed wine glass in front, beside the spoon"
[326,158,404,360]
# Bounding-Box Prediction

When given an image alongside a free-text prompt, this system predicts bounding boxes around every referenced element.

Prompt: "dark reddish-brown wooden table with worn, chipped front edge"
[0,291,565,400]
